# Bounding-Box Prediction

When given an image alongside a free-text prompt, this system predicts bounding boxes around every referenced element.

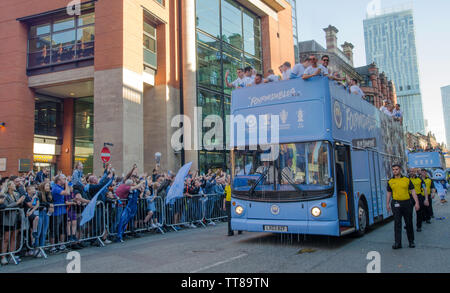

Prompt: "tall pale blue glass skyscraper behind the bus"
[364,8,425,134]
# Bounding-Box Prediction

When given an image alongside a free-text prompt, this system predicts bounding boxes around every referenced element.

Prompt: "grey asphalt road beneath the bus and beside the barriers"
[0,195,450,273]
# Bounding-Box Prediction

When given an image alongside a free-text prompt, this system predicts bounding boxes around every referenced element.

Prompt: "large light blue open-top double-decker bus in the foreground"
[230,77,406,236]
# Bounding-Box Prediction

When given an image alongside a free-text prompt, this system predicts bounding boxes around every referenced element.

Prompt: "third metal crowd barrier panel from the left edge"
[106,196,165,236]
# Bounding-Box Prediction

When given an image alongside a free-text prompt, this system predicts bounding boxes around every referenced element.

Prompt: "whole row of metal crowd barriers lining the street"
[0,194,227,264]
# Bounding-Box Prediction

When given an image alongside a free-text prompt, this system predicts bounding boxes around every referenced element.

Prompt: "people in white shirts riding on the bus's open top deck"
[225,55,403,123]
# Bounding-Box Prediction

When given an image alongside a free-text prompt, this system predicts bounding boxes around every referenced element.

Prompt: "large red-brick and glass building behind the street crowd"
[0,0,294,176]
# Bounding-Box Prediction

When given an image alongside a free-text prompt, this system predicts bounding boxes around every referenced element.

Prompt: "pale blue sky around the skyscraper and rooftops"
[297,0,450,145]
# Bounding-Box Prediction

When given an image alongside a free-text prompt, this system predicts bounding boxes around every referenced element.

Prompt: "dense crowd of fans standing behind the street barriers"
[0,162,230,265]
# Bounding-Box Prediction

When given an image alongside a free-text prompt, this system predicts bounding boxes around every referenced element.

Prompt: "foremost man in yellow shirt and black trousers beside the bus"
[386,164,419,249]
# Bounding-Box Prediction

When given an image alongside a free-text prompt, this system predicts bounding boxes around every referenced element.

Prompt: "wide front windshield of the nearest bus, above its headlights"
[233,141,333,199]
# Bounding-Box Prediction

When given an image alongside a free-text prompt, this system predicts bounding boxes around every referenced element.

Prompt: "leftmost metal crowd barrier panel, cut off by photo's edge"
[0,208,26,265]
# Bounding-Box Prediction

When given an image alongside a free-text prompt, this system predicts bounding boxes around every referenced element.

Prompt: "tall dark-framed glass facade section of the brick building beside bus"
[196,0,263,171]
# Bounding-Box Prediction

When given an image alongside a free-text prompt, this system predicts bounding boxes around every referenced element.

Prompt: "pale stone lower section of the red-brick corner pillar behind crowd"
[94,68,144,175]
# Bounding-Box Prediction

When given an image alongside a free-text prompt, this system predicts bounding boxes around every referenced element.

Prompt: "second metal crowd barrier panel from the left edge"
[26,201,106,258]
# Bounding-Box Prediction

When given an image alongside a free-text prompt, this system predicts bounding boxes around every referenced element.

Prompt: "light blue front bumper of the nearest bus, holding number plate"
[231,218,339,236]
